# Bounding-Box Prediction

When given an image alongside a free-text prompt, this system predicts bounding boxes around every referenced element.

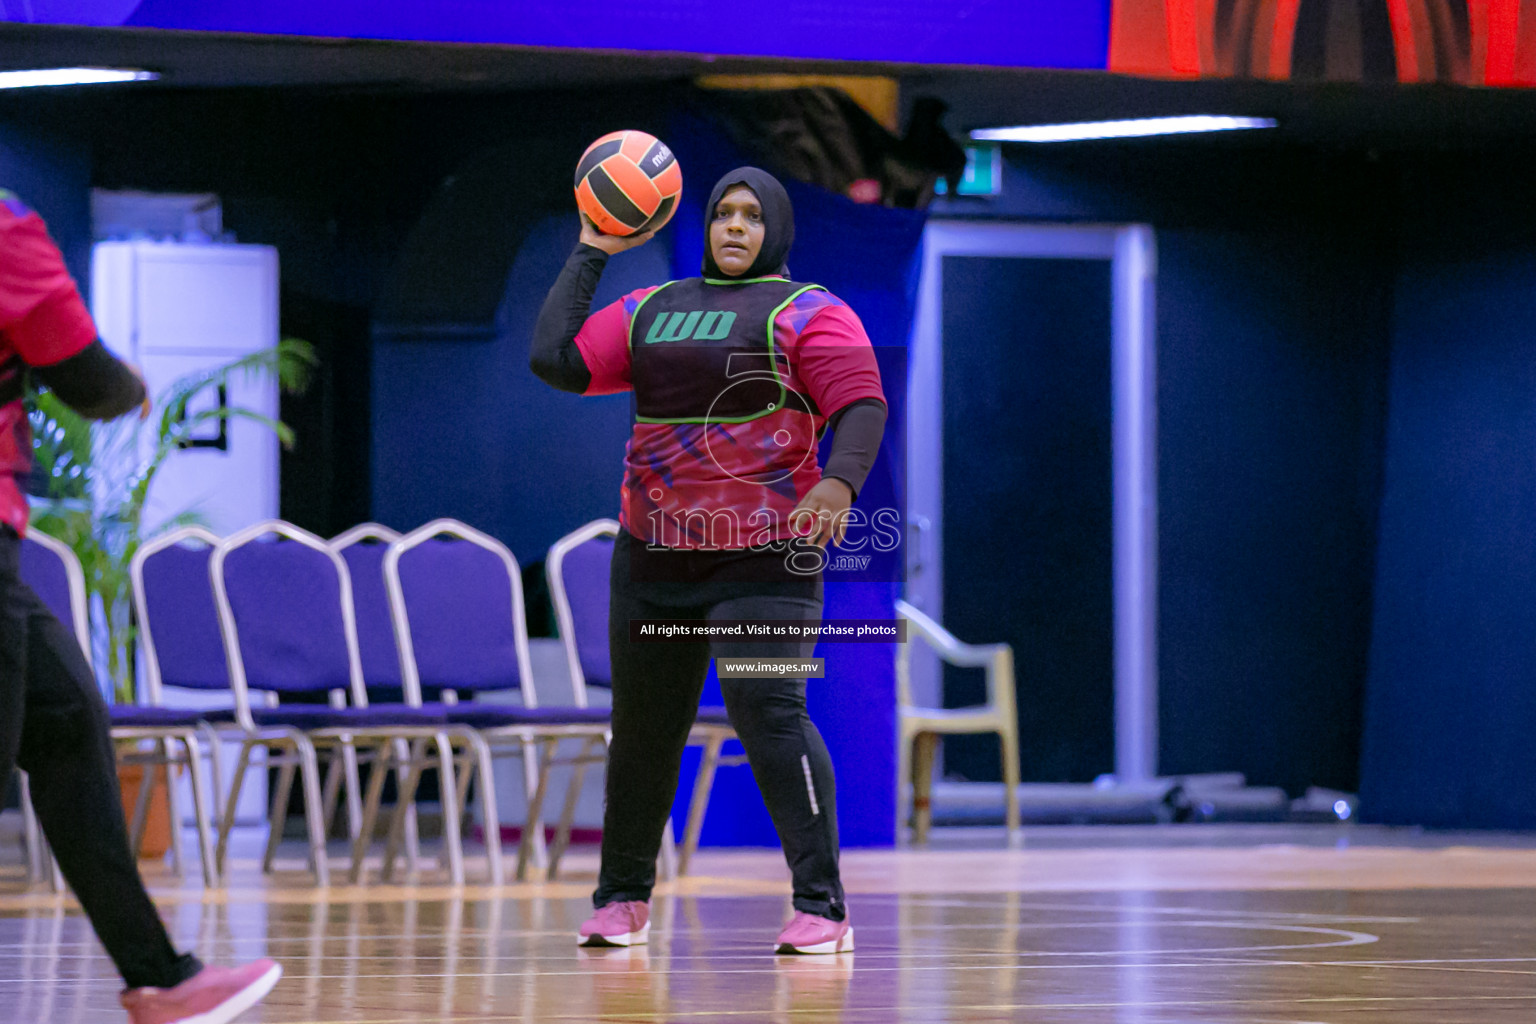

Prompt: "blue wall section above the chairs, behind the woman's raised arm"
[373,210,670,563]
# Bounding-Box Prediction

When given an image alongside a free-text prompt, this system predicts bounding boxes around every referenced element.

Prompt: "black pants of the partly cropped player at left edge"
[0,527,201,989]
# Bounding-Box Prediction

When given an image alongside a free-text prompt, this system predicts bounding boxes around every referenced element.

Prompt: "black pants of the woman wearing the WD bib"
[593,580,846,921]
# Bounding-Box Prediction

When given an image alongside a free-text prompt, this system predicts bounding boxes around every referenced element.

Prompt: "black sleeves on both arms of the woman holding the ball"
[528,243,886,497]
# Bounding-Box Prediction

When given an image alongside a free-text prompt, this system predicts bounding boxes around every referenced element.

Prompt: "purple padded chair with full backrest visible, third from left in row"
[209,520,464,886]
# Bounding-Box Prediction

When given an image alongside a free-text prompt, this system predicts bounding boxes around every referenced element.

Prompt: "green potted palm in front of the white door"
[29,338,316,857]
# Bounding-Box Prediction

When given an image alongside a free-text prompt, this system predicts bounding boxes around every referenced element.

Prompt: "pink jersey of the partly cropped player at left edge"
[0,190,95,533]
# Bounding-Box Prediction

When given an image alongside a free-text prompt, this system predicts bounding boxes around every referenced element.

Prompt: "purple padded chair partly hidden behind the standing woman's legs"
[544,519,746,875]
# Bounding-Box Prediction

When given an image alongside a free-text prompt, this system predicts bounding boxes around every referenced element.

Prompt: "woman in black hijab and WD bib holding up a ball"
[531,167,886,953]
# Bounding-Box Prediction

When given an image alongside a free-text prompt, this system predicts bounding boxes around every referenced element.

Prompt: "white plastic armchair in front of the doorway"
[895,600,1018,843]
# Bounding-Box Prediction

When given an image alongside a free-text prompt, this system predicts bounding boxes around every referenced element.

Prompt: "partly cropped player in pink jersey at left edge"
[0,192,283,1024]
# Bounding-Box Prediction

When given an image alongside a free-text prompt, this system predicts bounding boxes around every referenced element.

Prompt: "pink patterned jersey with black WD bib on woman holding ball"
[574,276,885,550]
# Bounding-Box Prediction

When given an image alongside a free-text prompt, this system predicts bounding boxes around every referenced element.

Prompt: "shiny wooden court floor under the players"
[0,837,1536,1024]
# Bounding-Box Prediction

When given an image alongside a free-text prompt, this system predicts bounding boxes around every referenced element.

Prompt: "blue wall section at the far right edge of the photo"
[1361,161,1536,829]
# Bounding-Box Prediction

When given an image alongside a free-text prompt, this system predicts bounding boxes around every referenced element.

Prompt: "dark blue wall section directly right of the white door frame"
[1158,221,1389,794]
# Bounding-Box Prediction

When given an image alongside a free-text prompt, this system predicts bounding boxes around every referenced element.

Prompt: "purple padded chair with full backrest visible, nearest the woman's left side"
[384,519,608,884]
